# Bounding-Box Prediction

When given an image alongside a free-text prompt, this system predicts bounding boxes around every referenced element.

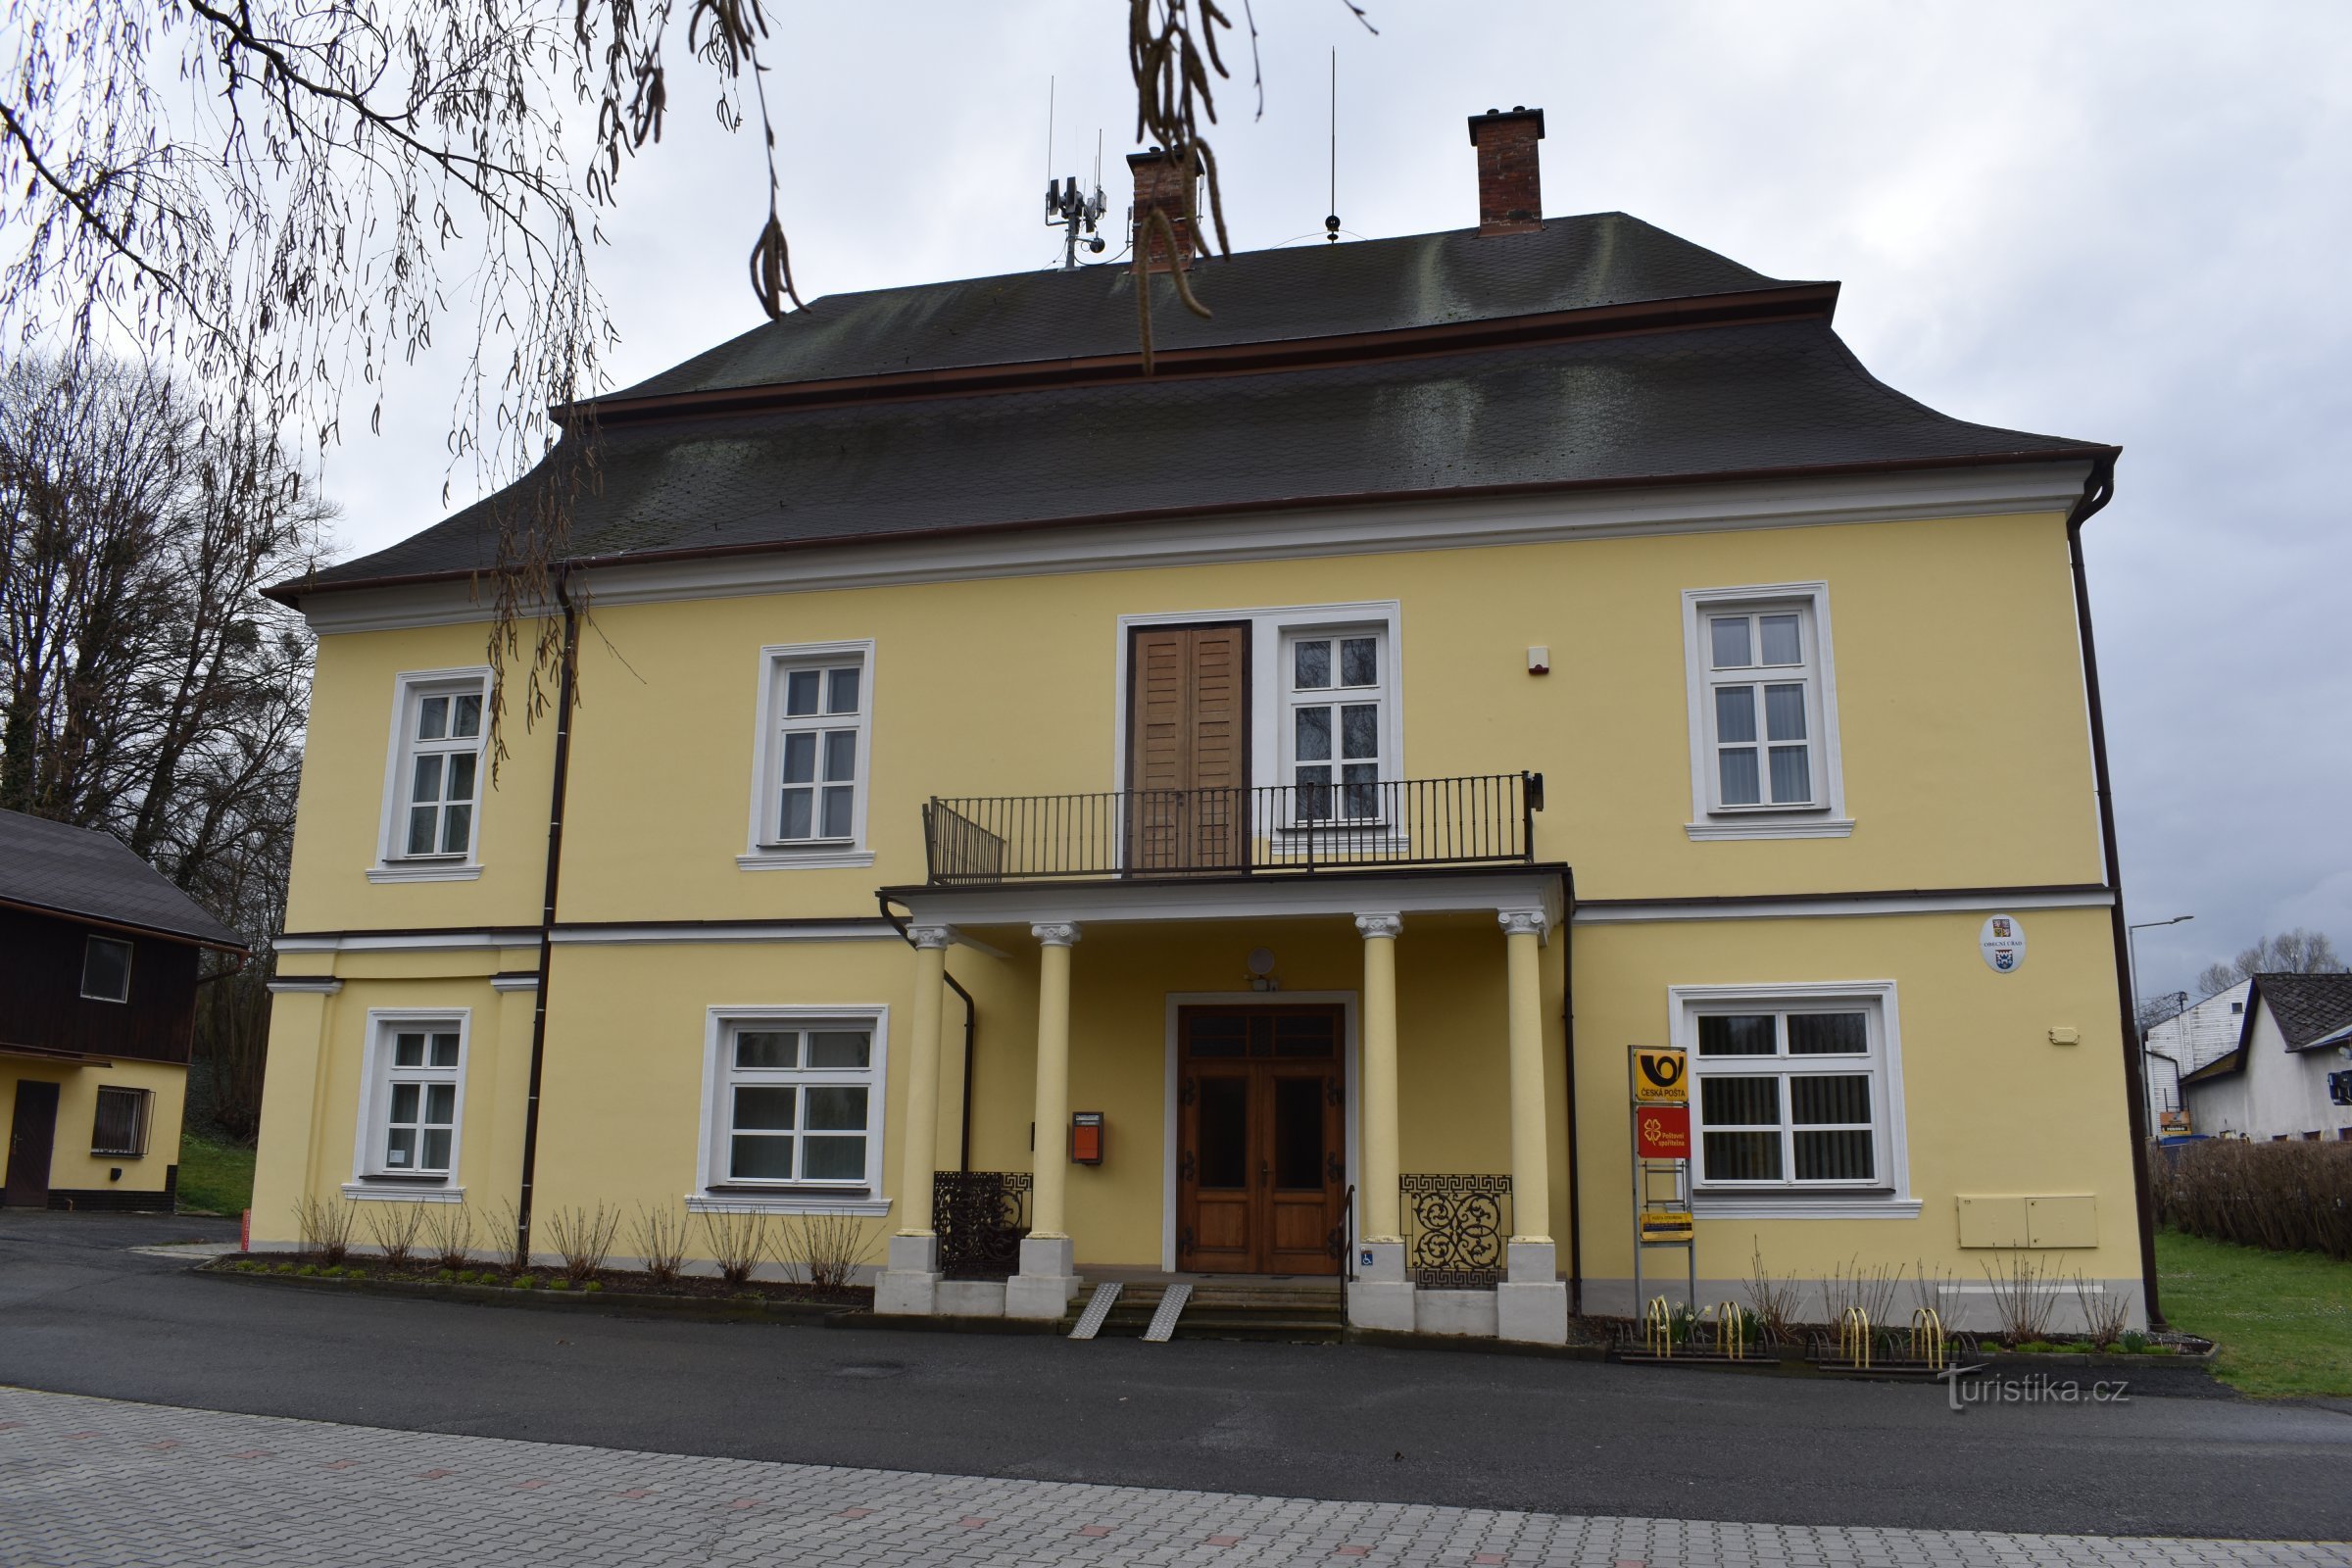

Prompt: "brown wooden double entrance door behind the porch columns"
[1176,1004,1348,1274]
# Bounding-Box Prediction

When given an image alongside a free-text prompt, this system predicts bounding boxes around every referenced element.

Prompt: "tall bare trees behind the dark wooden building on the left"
[0,358,329,1138]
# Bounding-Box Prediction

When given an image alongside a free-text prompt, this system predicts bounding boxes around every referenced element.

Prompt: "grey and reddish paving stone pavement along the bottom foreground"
[0,1390,2352,1568]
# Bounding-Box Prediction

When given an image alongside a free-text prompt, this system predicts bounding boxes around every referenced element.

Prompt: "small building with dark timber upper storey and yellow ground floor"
[0,811,245,1210]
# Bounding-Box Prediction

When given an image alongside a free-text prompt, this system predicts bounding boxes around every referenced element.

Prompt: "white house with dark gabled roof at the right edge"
[2182,973,2352,1140]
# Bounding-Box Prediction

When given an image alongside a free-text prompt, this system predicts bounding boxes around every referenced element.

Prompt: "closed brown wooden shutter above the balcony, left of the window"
[1127,620,1249,872]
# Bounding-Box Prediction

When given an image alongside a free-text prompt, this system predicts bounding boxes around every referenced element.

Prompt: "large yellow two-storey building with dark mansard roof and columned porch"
[254,111,2145,1340]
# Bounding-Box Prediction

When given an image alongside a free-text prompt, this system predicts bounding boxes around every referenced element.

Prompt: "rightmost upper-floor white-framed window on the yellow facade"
[1682,583,1853,839]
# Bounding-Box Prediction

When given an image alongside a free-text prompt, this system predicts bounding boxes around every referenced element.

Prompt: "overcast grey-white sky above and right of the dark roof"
[324,0,2352,995]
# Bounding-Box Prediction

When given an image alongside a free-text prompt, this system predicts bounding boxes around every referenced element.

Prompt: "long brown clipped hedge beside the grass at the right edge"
[2147,1138,2352,1260]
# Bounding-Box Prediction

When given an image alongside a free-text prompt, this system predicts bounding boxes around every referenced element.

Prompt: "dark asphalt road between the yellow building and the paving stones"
[0,1213,2352,1540]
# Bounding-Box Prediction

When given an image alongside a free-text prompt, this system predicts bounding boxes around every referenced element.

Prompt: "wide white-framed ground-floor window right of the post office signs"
[1670,980,1919,1218]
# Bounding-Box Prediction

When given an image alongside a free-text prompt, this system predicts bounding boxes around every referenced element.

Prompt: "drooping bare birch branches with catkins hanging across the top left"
[0,0,1369,764]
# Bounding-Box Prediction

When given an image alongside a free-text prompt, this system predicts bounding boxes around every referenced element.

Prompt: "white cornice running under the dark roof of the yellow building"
[304,459,2088,635]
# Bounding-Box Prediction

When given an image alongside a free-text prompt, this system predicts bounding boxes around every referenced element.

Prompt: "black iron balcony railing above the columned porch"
[922,773,1543,884]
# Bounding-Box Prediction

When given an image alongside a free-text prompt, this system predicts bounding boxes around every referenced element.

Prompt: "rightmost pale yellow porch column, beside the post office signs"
[1494,909,1569,1345]
